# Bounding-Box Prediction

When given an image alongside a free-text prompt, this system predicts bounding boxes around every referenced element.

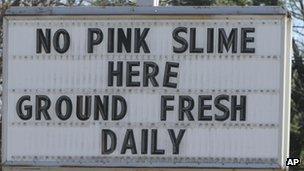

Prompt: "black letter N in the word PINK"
[117,28,131,53]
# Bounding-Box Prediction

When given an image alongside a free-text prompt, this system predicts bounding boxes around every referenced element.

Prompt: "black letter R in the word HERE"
[143,62,159,87]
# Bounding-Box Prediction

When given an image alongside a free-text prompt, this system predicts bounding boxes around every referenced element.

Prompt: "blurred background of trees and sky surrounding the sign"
[0,0,304,169]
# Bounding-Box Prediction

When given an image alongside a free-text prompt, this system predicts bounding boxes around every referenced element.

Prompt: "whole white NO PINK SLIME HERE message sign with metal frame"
[3,7,291,168]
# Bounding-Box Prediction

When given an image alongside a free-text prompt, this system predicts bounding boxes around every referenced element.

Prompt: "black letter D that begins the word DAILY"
[101,129,117,154]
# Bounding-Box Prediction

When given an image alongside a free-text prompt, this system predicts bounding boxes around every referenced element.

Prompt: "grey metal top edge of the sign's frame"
[5,6,288,16]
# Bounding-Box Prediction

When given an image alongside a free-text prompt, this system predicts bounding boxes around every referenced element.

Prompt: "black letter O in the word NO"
[53,29,70,53]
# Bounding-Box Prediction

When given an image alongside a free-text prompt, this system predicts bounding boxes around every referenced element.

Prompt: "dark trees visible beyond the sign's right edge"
[287,0,304,168]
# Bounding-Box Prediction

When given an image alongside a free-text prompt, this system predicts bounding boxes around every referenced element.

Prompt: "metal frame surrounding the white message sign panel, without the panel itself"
[2,7,292,168]
